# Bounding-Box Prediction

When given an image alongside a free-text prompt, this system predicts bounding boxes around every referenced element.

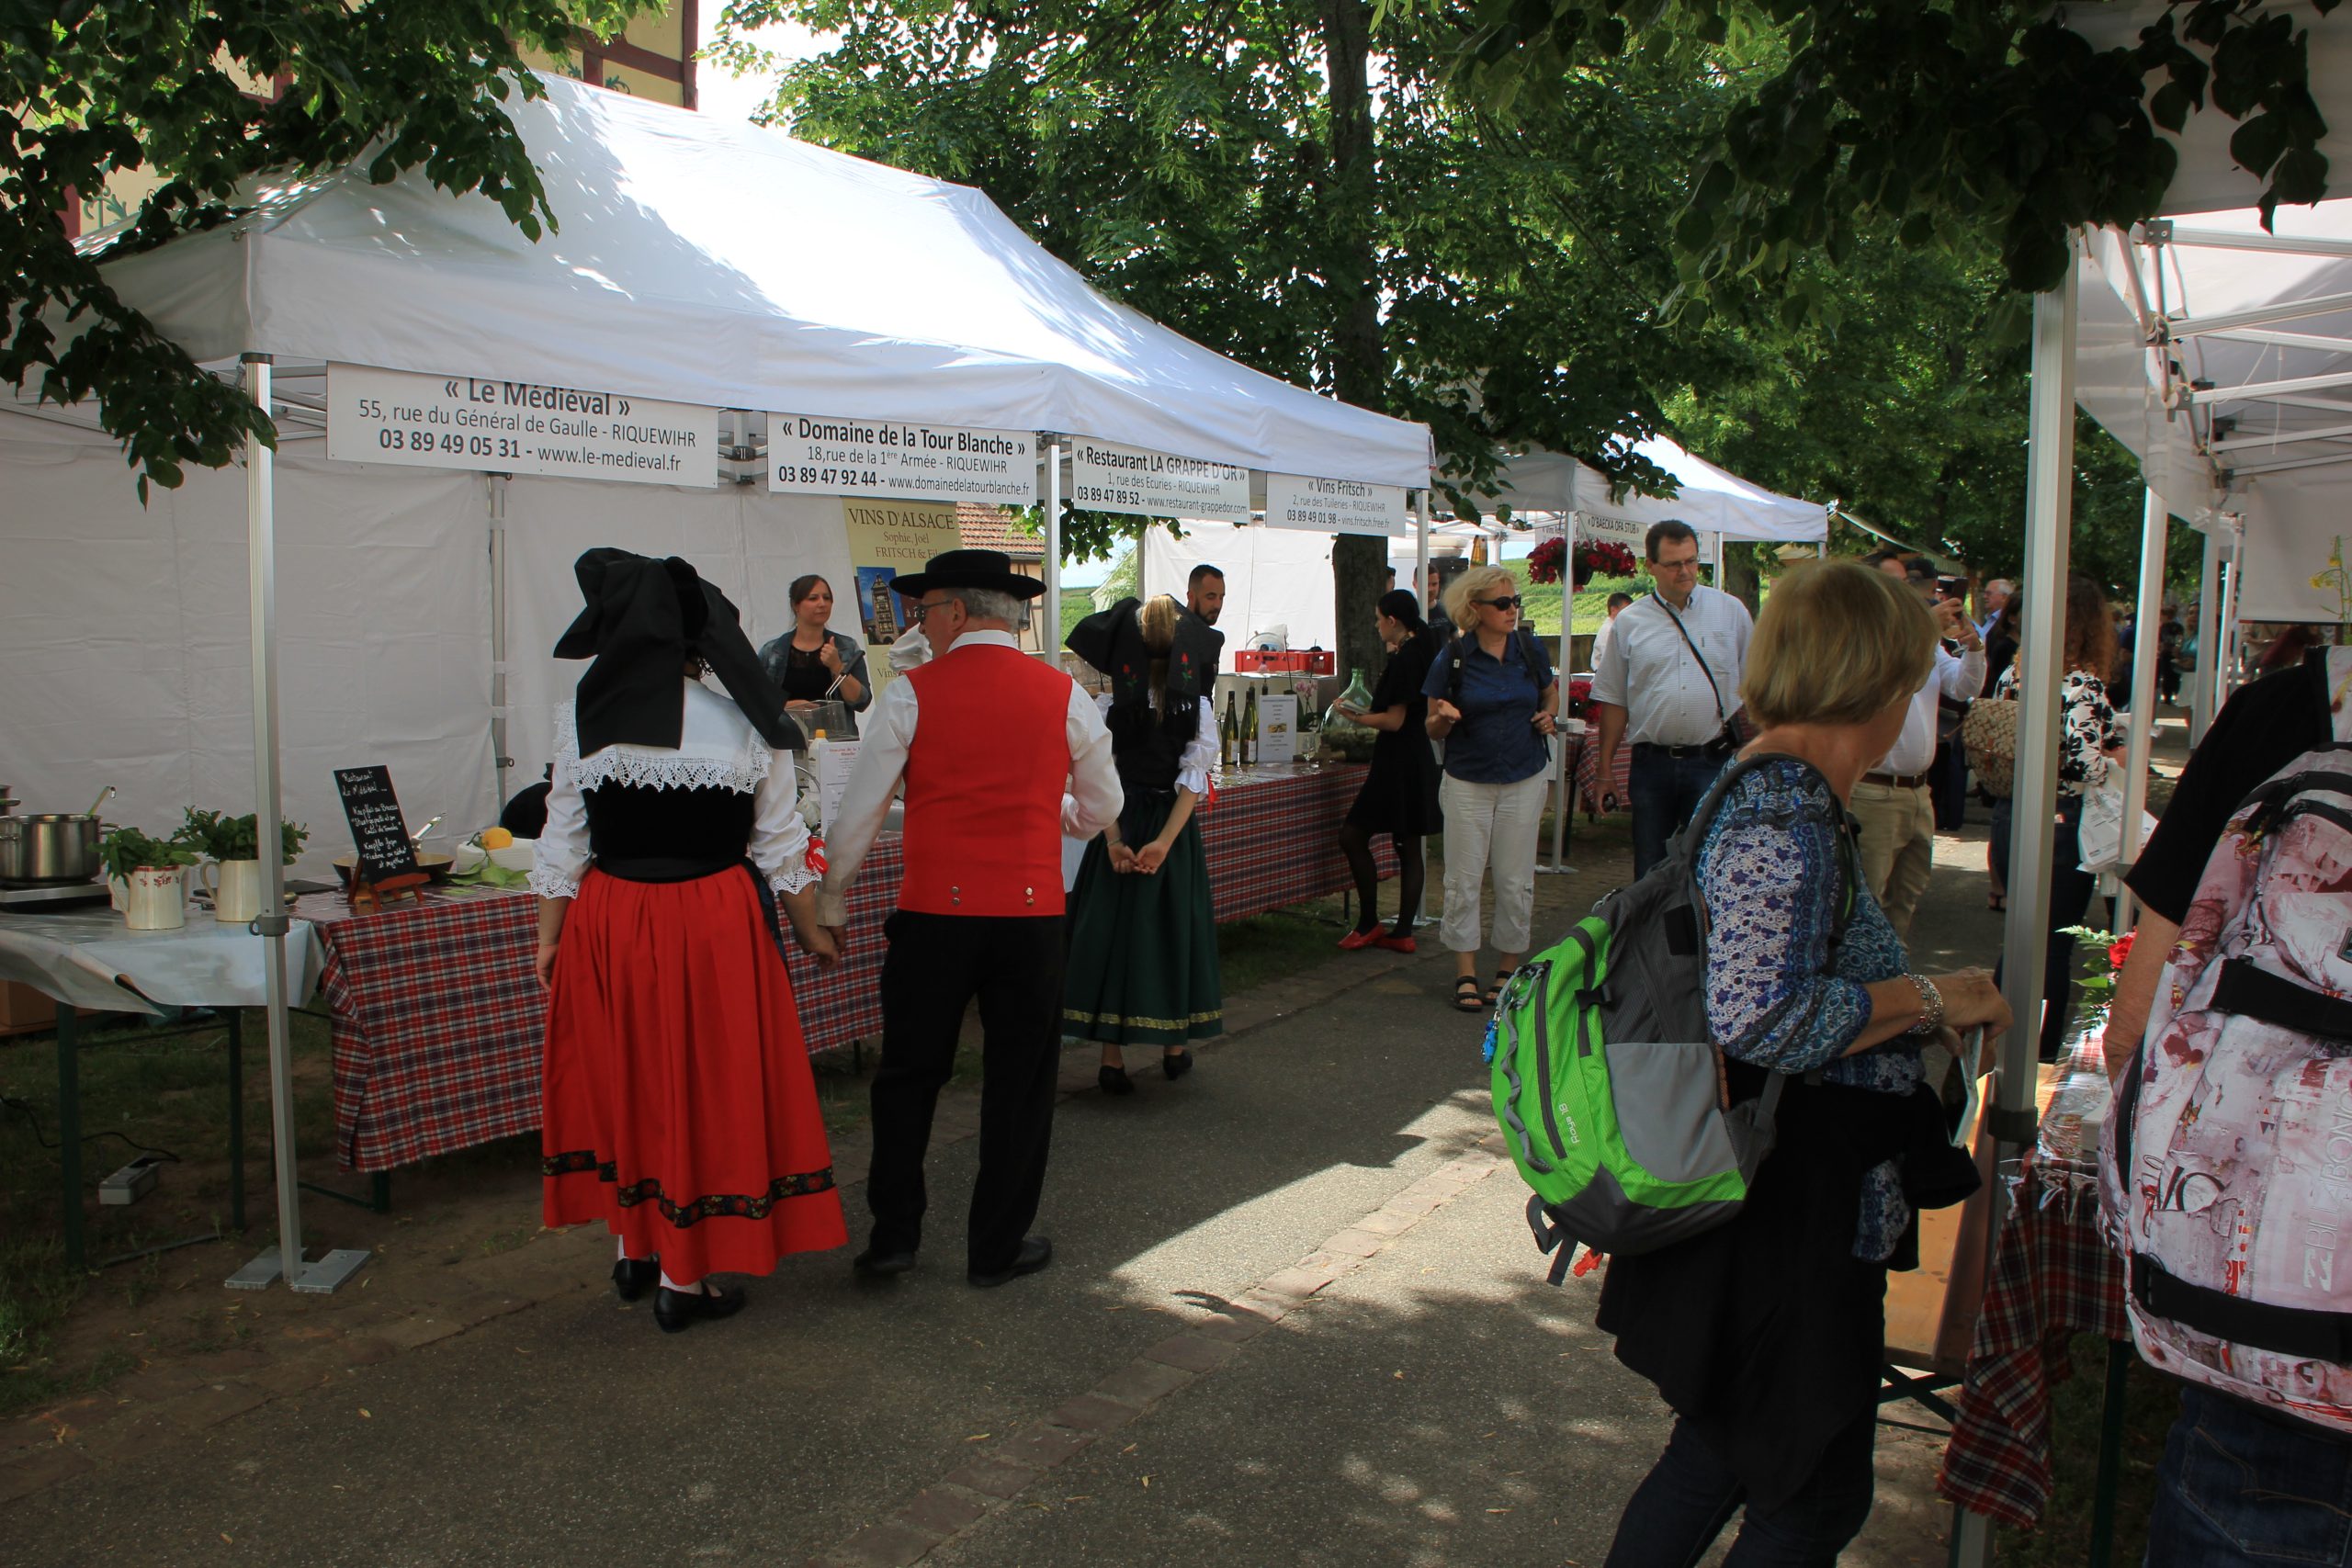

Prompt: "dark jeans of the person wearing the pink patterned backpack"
[2145,1387,2352,1568]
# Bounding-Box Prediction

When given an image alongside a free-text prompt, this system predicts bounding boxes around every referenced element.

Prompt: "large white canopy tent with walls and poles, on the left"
[0,77,1430,1291]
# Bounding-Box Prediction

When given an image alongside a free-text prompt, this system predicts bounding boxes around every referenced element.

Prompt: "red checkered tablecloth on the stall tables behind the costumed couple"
[294,766,1397,1170]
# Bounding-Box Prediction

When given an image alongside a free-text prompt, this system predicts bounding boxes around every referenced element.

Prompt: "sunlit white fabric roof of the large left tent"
[74,77,1430,489]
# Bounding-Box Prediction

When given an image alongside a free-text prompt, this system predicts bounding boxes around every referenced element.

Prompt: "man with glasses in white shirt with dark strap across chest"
[1592,520,1755,879]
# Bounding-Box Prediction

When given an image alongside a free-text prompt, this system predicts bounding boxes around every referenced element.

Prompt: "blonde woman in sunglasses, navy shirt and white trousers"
[1420,567,1559,1013]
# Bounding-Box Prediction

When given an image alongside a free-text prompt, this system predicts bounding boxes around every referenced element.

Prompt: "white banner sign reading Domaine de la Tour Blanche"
[767,413,1037,505]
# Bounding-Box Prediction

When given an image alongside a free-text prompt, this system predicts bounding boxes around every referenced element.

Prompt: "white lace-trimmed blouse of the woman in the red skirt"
[532,680,816,898]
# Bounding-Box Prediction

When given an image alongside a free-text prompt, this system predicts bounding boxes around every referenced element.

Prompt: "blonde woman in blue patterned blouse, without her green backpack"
[1600,562,2008,1568]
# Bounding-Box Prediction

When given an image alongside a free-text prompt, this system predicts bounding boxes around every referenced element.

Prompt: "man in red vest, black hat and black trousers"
[819,550,1122,1286]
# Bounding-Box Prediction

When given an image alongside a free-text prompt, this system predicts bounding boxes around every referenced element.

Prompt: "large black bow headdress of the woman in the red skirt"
[555,547,807,757]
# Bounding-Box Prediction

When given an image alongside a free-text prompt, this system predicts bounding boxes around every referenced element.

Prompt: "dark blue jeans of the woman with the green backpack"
[1604,1405,1879,1568]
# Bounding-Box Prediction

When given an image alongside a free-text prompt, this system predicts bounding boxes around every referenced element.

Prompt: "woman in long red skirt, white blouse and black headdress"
[532,550,847,1333]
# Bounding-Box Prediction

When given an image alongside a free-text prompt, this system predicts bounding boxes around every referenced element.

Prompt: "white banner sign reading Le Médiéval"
[327,365,719,489]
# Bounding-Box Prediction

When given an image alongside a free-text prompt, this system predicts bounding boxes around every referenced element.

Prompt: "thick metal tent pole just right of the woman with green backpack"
[1952,252,2082,1568]
